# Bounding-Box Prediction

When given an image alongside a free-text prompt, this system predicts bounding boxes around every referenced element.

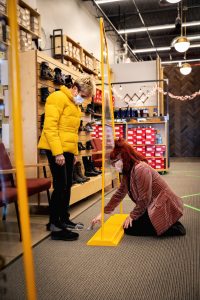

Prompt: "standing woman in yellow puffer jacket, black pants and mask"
[38,75,95,240]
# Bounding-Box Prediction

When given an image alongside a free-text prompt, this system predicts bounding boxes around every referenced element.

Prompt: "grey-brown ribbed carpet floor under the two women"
[0,161,200,300]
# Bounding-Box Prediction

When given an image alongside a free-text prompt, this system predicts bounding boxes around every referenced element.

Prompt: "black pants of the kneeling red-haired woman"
[124,210,186,236]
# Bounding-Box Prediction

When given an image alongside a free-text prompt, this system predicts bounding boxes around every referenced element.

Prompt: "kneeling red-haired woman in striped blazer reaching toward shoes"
[92,139,186,236]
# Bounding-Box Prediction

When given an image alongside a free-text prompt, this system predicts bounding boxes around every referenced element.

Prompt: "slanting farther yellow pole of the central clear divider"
[103,20,123,214]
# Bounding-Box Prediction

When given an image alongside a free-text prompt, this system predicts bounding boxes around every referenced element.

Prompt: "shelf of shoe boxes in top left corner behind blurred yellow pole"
[0,0,40,51]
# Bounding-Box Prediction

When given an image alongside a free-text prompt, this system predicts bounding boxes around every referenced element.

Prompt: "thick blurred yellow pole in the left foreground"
[8,0,36,300]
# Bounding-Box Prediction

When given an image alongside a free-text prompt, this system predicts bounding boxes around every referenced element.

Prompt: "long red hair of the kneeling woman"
[110,138,148,174]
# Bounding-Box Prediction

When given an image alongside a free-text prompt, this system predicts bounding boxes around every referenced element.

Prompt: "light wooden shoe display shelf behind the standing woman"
[17,50,112,204]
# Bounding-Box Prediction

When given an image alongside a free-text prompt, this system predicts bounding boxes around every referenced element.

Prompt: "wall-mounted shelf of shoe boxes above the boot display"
[54,35,100,76]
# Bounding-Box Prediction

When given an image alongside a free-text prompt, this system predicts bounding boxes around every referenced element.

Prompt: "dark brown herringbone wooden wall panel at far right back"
[164,66,200,157]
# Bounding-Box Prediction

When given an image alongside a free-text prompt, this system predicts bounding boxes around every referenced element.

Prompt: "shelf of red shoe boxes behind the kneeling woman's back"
[127,120,168,171]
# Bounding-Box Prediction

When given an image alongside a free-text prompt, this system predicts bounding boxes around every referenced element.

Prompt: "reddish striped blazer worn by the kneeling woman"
[104,162,183,235]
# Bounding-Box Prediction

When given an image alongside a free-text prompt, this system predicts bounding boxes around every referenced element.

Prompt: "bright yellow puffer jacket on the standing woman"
[38,86,81,156]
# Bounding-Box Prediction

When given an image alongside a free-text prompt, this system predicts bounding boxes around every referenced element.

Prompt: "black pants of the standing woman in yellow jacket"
[46,150,74,224]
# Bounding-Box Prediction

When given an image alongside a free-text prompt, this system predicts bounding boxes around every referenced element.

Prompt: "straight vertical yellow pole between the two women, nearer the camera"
[100,18,105,239]
